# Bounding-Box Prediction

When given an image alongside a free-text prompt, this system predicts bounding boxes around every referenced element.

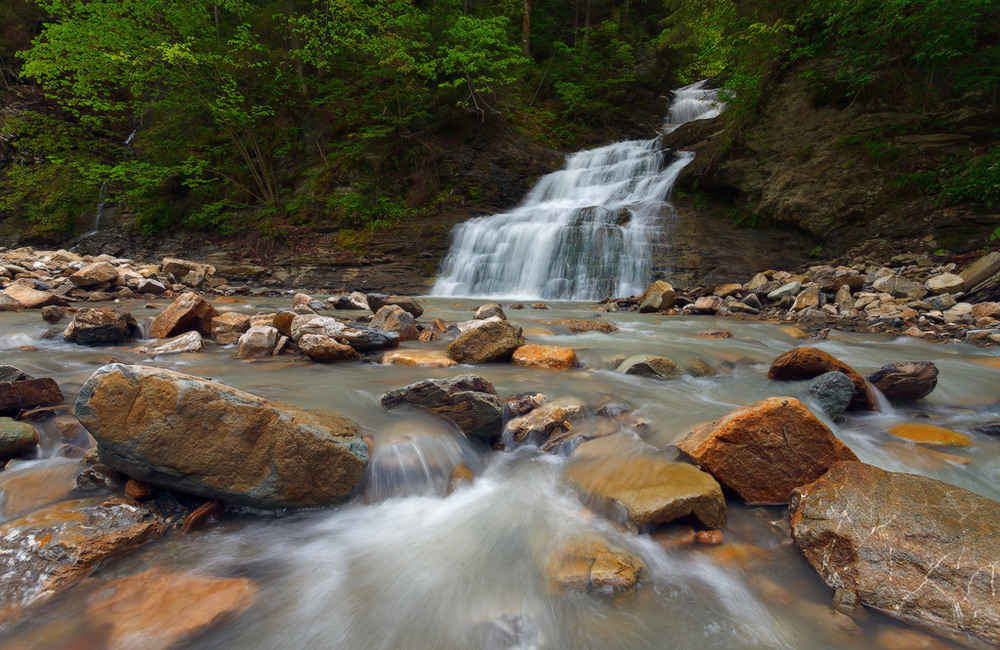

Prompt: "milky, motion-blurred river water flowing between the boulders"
[0,297,1000,648]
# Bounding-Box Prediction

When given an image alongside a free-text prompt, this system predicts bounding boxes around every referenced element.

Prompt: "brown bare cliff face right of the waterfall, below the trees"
[666,69,1000,256]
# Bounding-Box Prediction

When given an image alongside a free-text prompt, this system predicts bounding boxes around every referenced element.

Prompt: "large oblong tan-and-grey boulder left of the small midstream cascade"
[76,364,368,509]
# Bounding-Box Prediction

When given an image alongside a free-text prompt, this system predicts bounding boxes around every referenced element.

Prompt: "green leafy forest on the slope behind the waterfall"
[0,0,1000,243]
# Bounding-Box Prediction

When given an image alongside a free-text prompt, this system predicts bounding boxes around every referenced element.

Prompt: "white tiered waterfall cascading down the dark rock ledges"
[431,82,719,300]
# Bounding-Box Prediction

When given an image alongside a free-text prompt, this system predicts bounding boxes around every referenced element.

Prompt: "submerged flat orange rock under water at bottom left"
[87,568,258,650]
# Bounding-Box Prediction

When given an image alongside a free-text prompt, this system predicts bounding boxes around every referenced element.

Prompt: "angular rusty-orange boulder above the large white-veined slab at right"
[676,397,857,505]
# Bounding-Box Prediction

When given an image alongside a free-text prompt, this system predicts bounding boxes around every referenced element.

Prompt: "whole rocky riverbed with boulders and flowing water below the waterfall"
[0,244,1000,648]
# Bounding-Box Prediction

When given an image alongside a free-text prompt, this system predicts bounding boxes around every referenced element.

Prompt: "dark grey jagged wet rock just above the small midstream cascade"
[382,375,502,439]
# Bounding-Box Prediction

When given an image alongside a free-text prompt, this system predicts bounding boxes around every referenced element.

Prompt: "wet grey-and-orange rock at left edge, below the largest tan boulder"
[0,498,167,621]
